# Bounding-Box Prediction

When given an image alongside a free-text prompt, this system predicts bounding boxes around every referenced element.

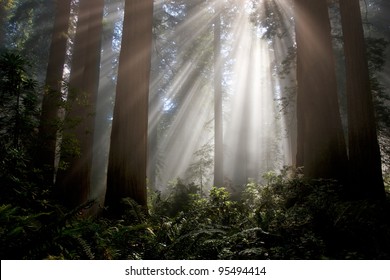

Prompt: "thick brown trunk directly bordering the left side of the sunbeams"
[106,0,153,212]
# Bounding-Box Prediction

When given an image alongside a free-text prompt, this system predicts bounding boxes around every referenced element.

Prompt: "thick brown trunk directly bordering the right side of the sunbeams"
[295,0,347,182]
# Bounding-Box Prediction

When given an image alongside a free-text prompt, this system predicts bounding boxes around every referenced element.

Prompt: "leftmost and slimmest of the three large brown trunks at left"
[39,0,71,183]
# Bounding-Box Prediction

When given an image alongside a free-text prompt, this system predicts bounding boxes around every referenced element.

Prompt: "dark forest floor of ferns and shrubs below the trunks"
[0,165,390,260]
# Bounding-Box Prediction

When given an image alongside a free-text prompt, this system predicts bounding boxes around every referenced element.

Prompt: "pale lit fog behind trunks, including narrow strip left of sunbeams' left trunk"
[87,1,296,201]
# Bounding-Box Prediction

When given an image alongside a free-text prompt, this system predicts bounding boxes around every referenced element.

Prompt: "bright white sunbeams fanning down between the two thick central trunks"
[149,1,292,192]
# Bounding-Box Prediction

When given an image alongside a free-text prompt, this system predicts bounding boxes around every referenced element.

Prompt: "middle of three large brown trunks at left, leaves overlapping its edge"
[58,0,104,207]
